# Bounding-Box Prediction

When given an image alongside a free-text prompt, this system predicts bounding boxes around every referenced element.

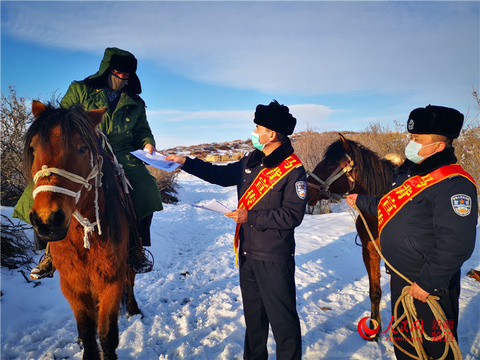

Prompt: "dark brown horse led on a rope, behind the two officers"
[307,134,396,341]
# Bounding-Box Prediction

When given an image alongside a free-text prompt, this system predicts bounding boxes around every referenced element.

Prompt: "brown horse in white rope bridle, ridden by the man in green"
[25,101,140,360]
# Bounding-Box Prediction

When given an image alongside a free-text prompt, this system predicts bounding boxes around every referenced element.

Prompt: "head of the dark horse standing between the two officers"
[307,134,357,206]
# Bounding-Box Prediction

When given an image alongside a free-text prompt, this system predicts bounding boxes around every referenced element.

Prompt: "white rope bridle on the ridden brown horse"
[33,155,103,249]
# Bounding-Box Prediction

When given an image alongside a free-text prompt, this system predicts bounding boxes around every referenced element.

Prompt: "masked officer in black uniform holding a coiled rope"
[347,105,478,359]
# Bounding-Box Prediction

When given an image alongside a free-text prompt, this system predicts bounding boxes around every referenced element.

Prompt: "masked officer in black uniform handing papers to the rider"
[167,101,306,360]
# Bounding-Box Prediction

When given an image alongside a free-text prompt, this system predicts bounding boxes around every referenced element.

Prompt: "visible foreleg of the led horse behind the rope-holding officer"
[356,218,382,341]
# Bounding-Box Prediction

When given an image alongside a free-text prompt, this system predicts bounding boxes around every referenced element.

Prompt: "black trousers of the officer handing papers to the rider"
[240,257,302,360]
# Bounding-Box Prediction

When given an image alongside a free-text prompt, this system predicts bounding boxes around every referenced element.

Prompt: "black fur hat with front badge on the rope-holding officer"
[407,105,463,139]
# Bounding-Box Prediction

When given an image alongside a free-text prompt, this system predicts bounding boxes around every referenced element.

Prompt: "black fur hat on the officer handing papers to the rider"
[253,100,297,135]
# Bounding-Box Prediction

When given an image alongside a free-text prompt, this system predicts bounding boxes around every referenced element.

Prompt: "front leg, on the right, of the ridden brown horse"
[98,282,123,360]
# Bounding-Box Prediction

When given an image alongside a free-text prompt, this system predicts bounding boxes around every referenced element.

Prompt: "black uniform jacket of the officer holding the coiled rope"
[357,147,478,294]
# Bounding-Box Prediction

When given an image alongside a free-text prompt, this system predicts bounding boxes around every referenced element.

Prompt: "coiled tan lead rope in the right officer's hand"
[353,204,462,360]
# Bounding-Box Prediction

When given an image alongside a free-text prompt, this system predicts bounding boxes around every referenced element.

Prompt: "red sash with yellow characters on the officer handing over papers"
[233,154,302,267]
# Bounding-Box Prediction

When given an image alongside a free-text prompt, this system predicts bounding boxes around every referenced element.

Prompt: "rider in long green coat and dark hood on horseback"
[14,48,163,279]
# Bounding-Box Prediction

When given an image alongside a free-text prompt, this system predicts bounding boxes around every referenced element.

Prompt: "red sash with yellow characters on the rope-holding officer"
[378,164,476,236]
